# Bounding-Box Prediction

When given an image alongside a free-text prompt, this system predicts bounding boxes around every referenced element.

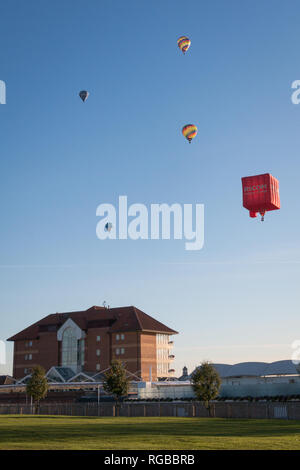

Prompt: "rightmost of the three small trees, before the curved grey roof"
[191,362,221,416]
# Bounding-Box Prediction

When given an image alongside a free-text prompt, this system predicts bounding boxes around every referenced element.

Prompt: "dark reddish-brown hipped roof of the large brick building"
[7,306,177,341]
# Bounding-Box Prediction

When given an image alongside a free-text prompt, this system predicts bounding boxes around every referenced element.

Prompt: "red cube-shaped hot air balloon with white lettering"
[242,173,280,221]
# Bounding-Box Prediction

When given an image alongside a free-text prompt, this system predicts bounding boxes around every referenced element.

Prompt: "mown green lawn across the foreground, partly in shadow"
[0,415,300,450]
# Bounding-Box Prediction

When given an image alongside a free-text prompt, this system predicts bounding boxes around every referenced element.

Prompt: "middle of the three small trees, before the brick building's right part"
[103,360,129,412]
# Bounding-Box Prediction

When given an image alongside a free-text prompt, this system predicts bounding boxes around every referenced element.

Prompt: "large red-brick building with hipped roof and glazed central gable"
[8,306,177,380]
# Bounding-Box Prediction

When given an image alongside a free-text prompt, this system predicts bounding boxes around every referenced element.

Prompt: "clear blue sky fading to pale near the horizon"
[0,0,300,374]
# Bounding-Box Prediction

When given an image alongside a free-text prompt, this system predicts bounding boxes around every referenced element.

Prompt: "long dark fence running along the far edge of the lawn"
[0,402,300,420]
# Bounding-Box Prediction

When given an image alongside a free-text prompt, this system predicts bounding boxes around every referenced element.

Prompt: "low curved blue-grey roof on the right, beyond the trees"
[188,359,300,379]
